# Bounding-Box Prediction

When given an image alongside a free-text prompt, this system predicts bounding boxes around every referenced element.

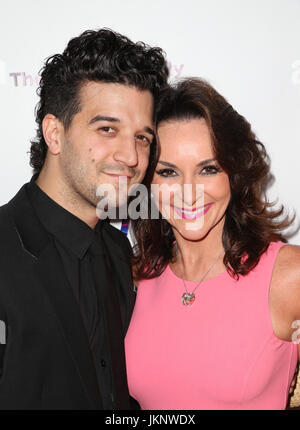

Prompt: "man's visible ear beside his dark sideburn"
[42,113,63,155]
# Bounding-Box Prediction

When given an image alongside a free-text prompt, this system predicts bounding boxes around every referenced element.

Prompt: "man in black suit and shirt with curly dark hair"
[0,29,168,409]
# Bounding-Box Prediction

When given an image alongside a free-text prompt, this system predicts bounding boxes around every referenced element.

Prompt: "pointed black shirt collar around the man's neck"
[28,175,101,259]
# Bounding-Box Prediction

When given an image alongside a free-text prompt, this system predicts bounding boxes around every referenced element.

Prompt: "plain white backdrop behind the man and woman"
[0,0,300,244]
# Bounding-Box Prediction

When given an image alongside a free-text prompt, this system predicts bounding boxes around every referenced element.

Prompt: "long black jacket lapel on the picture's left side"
[7,185,102,409]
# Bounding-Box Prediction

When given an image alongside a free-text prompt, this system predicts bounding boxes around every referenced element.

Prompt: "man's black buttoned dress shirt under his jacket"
[28,180,115,409]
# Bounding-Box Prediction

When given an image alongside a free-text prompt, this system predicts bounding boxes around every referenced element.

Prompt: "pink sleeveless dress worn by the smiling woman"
[125,242,297,410]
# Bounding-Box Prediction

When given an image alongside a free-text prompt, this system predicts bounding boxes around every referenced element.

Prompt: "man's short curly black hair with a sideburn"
[30,28,169,173]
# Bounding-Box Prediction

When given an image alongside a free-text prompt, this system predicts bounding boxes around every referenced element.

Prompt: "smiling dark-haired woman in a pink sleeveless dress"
[125,79,300,410]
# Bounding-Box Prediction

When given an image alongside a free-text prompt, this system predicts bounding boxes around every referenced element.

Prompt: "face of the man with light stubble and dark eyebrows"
[59,82,153,212]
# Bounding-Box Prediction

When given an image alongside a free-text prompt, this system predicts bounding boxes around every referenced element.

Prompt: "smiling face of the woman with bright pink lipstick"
[152,118,230,240]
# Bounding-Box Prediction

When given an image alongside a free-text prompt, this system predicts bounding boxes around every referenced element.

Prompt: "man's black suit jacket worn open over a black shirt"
[0,185,135,409]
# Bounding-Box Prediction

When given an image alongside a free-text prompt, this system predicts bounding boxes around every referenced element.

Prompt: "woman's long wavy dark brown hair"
[131,78,294,280]
